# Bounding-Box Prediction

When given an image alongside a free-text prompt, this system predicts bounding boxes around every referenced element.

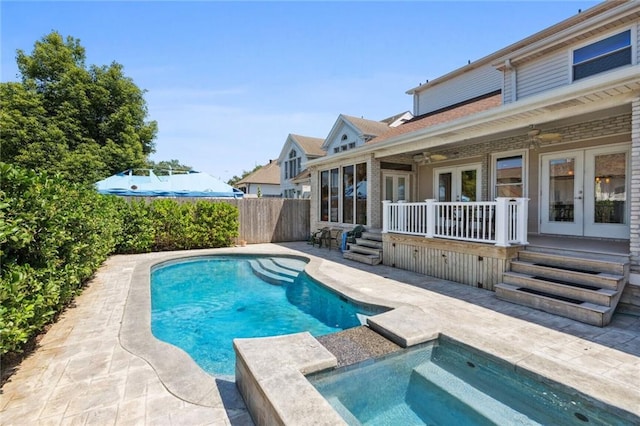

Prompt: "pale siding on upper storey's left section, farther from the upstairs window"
[414,65,503,115]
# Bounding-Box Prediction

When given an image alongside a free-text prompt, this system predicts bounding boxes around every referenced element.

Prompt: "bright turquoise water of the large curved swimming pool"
[151,256,382,377]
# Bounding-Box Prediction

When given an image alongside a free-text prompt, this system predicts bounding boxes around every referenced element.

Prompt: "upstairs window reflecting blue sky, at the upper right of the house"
[573,30,631,81]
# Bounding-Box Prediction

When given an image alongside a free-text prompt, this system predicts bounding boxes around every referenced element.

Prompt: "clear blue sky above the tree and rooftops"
[0,0,598,181]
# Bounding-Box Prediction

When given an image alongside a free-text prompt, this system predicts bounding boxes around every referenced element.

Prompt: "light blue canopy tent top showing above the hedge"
[96,169,244,198]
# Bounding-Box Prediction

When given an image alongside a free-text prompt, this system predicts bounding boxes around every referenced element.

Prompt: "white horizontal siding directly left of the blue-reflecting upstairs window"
[516,49,571,100]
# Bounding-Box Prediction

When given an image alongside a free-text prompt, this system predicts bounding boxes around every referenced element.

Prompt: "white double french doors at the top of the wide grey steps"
[540,145,630,239]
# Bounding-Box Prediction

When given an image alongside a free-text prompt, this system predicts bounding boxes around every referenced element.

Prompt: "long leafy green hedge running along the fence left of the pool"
[0,163,238,354]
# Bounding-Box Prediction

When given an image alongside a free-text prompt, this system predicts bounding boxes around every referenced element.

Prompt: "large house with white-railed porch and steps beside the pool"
[308,1,640,326]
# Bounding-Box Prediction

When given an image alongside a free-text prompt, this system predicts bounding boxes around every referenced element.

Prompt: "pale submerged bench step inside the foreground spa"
[408,362,535,425]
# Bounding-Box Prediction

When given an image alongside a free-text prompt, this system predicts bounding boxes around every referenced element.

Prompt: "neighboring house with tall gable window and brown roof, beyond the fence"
[278,134,325,198]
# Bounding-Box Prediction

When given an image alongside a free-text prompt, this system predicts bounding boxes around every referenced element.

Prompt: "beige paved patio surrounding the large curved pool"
[0,242,640,425]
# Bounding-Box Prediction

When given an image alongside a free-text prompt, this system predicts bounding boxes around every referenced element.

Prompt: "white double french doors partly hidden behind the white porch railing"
[434,164,480,202]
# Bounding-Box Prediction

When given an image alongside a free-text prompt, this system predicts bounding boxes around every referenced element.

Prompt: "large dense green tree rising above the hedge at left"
[0,31,157,183]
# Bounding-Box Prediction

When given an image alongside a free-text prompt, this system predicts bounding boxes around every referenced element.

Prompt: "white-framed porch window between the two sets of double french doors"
[491,150,528,198]
